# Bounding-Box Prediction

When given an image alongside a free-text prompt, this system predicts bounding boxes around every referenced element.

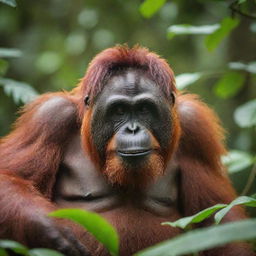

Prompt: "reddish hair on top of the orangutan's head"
[81,45,176,99]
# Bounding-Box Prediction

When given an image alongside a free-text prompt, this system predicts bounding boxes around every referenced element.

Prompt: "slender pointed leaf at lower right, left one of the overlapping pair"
[162,204,226,229]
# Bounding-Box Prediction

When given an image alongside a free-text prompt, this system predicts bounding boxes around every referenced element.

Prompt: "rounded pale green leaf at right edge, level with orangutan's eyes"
[234,99,256,128]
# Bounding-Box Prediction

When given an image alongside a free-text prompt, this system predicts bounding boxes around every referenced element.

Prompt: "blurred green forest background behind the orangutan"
[0,0,256,194]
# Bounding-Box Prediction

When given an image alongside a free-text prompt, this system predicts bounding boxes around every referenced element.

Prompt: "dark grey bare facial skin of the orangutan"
[91,69,172,163]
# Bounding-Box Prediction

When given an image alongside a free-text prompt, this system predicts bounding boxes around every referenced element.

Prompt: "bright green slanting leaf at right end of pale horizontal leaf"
[205,17,239,51]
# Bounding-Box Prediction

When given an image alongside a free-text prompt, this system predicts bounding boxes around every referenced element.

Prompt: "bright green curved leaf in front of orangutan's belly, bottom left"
[49,209,119,255]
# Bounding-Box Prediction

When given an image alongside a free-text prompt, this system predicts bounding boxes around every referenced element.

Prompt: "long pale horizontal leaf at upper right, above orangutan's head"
[167,24,220,39]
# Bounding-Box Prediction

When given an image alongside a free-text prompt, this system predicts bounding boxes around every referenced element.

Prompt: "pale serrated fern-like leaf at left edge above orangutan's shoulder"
[0,78,38,104]
